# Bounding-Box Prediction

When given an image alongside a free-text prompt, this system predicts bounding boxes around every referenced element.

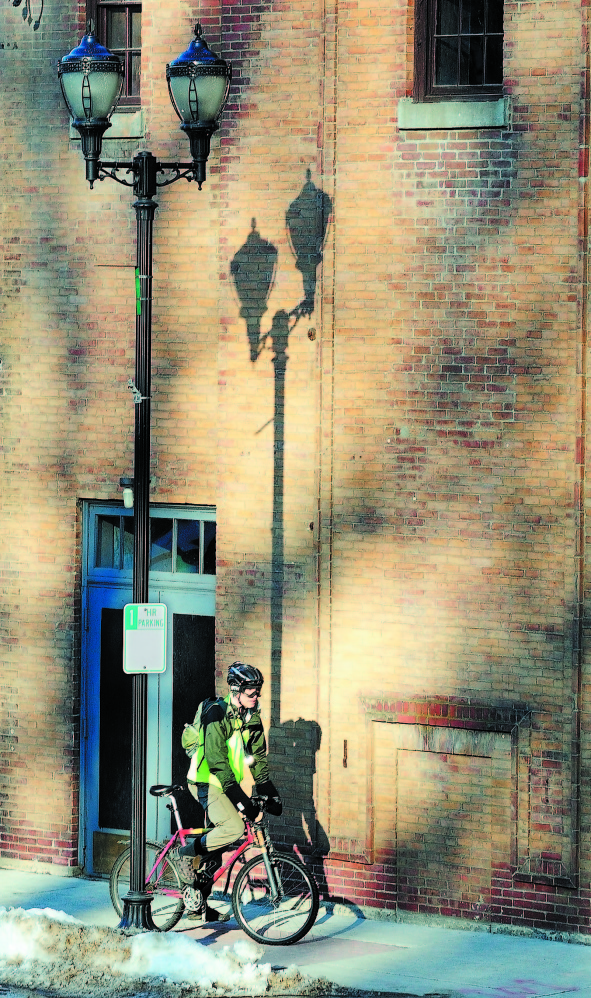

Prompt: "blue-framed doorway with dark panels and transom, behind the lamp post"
[80,503,215,874]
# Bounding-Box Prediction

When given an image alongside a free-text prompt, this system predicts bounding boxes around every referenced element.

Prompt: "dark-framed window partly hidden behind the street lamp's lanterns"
[88,0,142,108]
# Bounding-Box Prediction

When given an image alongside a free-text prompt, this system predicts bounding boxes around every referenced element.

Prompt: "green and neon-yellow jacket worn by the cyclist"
[187,694,269,793]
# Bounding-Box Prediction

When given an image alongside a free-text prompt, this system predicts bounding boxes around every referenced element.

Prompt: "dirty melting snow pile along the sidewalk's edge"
[0,908,298,998]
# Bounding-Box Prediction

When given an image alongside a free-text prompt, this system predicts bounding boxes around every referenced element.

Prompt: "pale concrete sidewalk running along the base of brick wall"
[0,869,591,998]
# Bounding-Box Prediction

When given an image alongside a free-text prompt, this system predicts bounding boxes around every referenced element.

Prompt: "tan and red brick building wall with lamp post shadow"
[0,0,591,934]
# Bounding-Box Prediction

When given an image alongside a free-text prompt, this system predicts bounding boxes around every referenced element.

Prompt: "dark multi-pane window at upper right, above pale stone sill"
[414,0,503,100]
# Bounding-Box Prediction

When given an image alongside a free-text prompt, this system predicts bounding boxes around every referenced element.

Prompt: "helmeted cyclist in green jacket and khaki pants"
[175,662,283,921]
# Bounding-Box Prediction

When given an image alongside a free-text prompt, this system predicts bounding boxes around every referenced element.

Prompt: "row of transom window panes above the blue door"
[92,510,216,575]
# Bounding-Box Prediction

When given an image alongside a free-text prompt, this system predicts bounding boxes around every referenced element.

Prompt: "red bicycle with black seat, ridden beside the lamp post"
[109,784,319,946]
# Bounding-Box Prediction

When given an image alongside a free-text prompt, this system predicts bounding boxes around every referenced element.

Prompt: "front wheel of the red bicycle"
[232,853,319,946]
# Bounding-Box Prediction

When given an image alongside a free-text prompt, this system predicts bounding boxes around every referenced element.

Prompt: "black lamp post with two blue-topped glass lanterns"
[58,17,232,930]
